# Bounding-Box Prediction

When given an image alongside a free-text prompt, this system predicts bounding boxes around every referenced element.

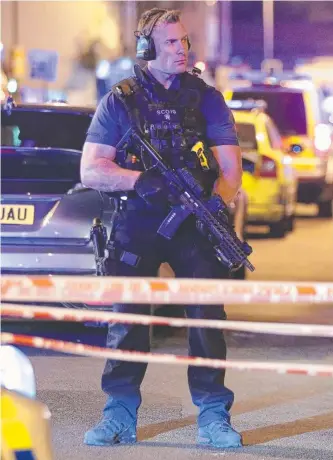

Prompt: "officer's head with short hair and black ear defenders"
[135,8,190,74]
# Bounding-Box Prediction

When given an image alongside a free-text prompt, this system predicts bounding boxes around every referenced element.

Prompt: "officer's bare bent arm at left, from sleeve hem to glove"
[81,142,140,192]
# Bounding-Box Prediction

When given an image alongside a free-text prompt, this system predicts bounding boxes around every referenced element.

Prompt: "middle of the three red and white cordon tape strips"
[1,304,333,337]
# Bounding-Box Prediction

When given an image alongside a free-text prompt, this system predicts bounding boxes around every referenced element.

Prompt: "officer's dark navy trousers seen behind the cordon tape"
[102,203,234,426]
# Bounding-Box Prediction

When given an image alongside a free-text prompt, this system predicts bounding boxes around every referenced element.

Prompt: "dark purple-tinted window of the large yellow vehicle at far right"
[232,90,307,136]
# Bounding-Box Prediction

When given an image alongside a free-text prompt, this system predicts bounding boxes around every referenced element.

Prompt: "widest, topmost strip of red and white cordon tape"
[1,275,333,305]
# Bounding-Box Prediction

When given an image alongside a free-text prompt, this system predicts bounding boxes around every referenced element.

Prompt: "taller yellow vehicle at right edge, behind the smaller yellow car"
[224,72,333,217]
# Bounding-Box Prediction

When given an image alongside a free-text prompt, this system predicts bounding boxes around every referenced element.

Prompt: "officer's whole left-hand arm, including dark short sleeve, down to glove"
[81,93,140,192]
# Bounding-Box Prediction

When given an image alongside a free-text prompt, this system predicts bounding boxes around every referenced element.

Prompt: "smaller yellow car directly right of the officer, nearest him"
[228,100,298,238]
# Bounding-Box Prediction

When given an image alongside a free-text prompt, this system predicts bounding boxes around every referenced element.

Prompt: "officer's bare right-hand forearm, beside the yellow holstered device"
[211,145,242,204]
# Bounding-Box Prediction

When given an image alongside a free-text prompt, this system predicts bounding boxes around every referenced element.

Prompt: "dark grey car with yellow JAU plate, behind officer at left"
[1,99,107,275]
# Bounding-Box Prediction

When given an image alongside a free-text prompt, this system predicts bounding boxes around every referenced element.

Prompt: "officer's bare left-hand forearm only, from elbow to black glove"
[81,158,141,192]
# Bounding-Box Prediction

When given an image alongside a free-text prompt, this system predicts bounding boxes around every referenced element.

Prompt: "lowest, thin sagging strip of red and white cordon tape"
[0,333,333,377]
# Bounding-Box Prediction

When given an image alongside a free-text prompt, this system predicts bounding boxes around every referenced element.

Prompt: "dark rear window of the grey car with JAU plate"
[1,110,91,150]
